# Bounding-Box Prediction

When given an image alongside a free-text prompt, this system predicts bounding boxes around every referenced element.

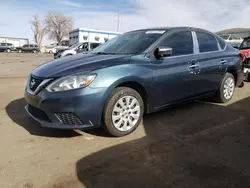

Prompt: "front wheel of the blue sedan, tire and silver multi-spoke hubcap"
[103,87,144,137]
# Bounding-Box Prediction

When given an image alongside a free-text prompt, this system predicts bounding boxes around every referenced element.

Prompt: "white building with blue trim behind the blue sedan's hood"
[69,28,121,45]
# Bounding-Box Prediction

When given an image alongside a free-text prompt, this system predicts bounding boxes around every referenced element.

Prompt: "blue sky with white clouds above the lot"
[0,0,250,44]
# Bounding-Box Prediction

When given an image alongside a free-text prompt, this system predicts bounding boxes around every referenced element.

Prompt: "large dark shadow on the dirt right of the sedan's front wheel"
[73,98,250,188]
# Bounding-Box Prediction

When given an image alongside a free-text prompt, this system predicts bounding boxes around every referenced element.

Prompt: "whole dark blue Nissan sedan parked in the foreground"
[25,27,243,136]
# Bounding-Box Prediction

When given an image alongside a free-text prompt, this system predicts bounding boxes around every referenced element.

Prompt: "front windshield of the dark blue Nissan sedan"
[92,30,166,54]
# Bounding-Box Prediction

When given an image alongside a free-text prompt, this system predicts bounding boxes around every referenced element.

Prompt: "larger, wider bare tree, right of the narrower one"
[45,13,73,45]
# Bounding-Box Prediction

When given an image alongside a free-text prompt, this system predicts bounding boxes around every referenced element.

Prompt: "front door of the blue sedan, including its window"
[149,30,200,107]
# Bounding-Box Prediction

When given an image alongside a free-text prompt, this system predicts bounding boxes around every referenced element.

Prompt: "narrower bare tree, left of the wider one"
[30,15,47,48]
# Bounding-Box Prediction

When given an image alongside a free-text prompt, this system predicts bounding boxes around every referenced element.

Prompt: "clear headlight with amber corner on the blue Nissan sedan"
[46,74,96,92]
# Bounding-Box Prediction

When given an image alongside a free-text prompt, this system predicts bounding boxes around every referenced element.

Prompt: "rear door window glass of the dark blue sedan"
[196,32,219,53]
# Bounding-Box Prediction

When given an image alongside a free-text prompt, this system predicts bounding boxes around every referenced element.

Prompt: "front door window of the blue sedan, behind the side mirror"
[161,31,194,56]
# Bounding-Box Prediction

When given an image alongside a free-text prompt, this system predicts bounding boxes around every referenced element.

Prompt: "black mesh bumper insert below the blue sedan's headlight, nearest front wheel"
[55,112,83,125]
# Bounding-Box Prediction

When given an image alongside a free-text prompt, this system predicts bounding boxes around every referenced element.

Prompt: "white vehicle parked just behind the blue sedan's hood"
[54,42,101,59]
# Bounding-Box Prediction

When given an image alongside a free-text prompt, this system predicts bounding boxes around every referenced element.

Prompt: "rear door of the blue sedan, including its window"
[192,31,227,94]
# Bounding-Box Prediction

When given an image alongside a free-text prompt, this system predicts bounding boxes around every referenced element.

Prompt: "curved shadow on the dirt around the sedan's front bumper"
[5,98,81,138]
